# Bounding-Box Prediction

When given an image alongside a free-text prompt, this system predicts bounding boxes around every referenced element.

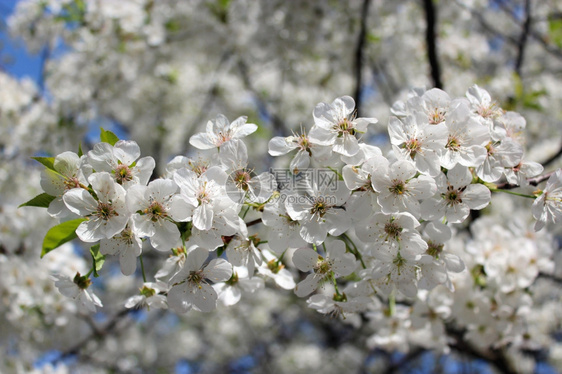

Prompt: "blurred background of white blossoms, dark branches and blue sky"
[0,0,562,373]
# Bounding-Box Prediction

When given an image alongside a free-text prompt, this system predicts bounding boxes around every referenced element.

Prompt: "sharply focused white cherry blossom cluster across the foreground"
[31,86,562,324]
